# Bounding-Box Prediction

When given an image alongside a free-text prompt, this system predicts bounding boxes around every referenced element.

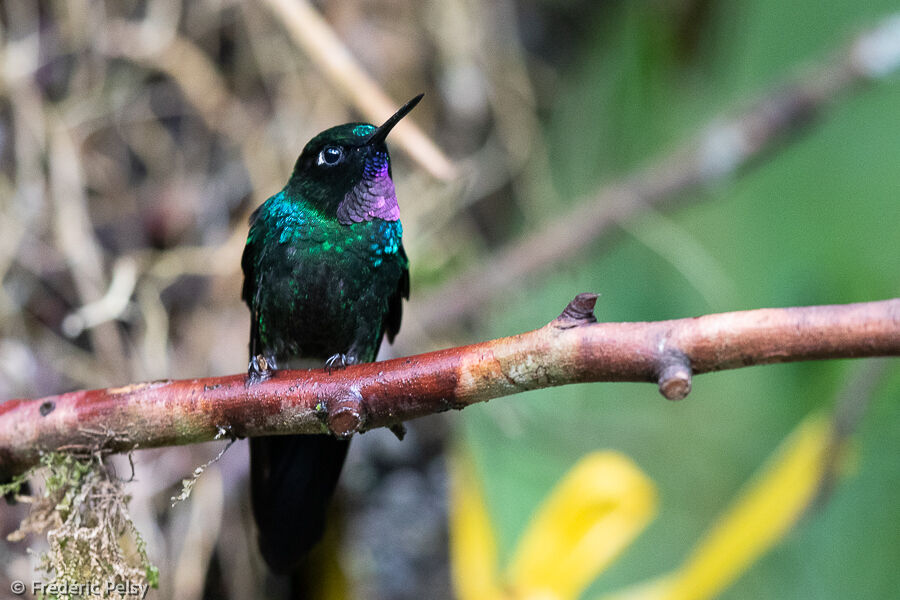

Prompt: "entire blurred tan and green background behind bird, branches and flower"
[0,0,900,599]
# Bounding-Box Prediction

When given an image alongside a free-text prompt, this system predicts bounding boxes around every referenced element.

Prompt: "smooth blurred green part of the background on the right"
[461,0,900,599]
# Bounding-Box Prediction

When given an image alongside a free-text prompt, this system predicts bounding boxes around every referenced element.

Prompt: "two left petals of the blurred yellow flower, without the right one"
[450,452,656,600]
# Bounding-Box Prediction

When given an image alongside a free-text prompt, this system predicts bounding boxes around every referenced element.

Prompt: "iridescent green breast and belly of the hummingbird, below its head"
[243,188,409,364]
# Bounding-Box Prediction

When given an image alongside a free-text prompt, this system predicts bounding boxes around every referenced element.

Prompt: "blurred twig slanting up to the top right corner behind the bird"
[410,14,900,335]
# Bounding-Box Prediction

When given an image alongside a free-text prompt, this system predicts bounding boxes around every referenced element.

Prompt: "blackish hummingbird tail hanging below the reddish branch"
[250,435,350,574]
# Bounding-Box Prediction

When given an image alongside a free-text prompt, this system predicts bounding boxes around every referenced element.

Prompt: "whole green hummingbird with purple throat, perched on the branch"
[241,94,424,574]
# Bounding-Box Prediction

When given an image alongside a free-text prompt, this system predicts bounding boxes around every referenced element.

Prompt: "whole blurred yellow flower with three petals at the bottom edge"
[450,415,848,600]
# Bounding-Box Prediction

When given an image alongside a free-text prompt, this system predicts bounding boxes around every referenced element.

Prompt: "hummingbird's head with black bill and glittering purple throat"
[288,94,423,225]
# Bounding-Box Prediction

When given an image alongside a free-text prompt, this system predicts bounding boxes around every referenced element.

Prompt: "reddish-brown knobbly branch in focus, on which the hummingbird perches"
[0,294,900,474]
